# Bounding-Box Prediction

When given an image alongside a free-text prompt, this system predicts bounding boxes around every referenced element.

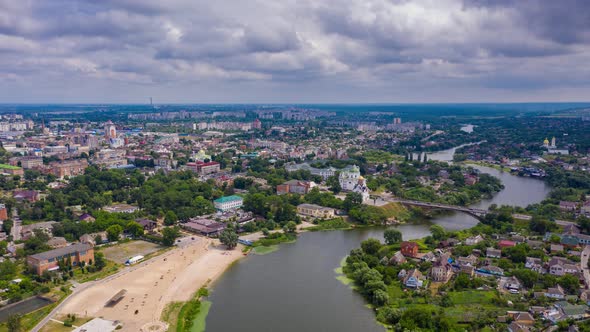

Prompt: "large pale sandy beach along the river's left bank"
[60,238,243,332]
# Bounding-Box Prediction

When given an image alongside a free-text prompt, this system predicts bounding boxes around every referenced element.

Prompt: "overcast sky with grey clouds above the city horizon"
[0,0,590,103]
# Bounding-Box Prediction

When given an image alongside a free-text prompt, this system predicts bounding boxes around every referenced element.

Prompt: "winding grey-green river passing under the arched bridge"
[206,148,550,332]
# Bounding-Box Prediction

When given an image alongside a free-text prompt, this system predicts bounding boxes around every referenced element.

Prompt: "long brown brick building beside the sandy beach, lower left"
[27,243,94,275]
